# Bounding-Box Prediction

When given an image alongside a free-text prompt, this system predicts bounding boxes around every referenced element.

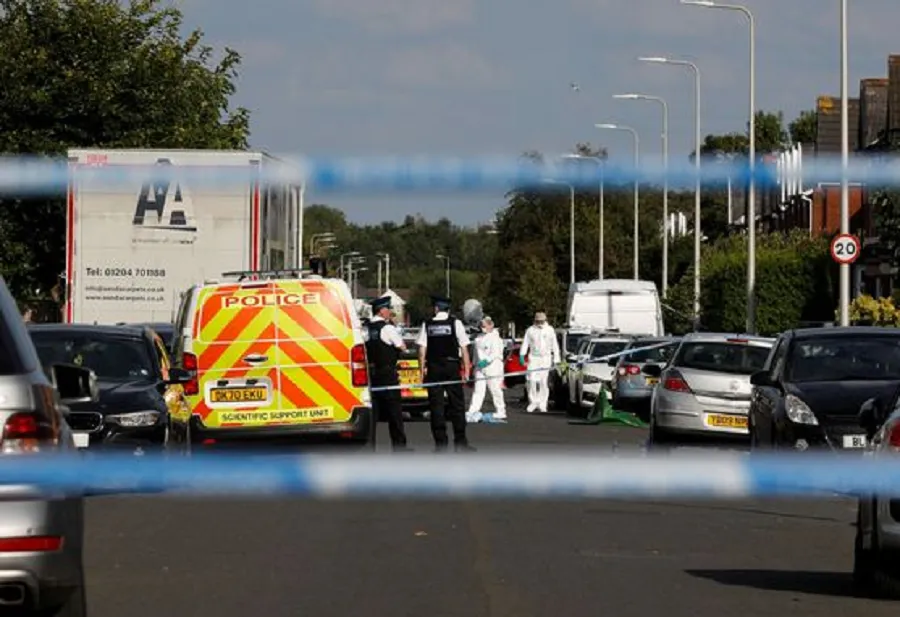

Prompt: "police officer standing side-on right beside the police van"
[366,296,410,452]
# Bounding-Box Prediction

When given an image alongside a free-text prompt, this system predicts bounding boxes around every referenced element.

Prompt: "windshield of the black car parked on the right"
[785,336,900,382]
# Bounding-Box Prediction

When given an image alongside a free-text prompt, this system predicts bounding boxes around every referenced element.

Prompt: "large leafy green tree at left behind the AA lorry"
[0,0,249,297]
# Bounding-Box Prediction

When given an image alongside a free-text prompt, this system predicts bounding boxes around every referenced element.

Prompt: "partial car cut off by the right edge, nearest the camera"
[853,389,900,599]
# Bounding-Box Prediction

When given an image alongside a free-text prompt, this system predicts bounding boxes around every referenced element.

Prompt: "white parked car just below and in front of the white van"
[568,336,634,415]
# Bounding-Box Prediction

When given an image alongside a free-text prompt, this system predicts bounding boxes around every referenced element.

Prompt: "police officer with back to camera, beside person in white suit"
[416,296,475,452]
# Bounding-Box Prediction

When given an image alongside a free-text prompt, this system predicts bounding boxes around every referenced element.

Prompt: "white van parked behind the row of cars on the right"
[566,279,664,336]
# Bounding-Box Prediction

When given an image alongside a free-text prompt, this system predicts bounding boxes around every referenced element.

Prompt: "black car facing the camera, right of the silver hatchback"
[749,326,900,451]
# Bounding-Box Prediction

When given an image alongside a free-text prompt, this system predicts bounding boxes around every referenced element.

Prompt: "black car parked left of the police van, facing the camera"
[28,324,188,449]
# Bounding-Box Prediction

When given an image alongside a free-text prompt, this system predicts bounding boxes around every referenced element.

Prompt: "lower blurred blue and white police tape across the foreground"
[0,451,900,499]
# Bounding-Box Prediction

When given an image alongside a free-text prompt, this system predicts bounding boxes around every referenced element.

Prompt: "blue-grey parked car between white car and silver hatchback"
[608,337,680,420]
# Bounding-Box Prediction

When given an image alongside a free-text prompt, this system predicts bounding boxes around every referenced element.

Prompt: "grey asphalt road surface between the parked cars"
[86,390,897,617]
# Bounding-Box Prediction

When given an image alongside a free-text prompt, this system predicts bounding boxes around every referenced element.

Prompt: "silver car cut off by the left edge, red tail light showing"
[0,277,97,617]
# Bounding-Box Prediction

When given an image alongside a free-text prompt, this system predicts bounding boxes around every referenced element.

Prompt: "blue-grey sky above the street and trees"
[175,0,900,225]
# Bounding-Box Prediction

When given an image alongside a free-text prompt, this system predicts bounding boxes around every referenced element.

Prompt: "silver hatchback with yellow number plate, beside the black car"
[642,333,775,444]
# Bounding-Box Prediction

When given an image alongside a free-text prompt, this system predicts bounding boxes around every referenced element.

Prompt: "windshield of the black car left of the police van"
[31,329,155,381]
